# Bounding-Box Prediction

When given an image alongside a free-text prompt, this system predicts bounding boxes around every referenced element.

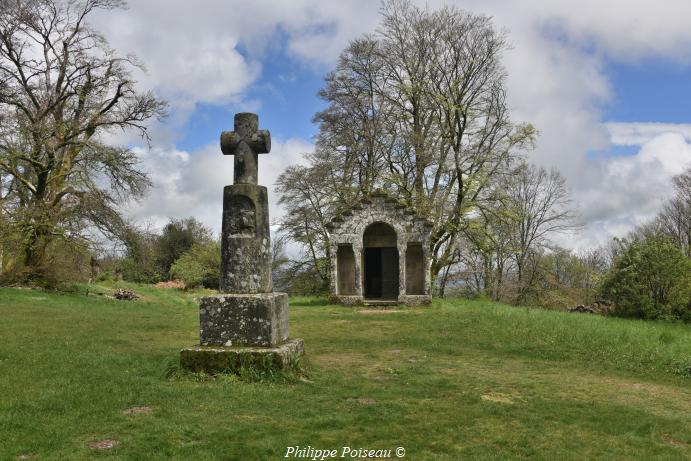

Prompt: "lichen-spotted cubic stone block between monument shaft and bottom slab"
[199,293,288,347]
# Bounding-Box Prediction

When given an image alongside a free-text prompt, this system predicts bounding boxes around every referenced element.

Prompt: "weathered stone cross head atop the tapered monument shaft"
[221,112,271,184]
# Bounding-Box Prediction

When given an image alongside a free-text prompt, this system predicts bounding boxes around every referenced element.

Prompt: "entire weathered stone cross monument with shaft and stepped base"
[180,113,304,372]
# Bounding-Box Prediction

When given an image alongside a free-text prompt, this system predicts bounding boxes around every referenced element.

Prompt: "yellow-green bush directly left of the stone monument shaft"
[170,242,221,289]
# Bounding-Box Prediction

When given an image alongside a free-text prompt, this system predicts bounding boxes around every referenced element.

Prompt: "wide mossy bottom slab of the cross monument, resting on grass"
[180,339,305,373]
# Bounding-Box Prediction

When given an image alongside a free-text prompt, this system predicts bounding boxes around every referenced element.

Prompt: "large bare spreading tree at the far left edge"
[0,0,165,275]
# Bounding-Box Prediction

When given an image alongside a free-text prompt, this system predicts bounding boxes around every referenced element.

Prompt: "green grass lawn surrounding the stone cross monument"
[0,286,691,460]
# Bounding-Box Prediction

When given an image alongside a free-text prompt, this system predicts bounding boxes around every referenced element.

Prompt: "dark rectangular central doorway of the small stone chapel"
[364,247,398,299]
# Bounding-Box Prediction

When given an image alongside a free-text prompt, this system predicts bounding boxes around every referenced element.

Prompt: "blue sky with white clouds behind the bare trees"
[91,0,691,250]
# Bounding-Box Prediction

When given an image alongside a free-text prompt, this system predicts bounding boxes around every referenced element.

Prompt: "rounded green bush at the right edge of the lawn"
[602,236,691,321]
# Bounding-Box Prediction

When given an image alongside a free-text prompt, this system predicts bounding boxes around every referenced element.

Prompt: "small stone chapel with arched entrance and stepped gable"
[327,191,432,306]
